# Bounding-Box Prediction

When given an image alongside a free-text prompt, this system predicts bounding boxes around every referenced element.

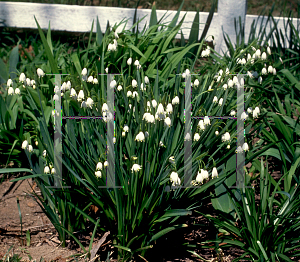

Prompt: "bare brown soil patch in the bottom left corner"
[0,171,78,261]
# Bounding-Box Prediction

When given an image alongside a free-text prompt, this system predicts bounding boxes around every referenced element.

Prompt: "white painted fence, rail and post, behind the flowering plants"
[0,0,300,52]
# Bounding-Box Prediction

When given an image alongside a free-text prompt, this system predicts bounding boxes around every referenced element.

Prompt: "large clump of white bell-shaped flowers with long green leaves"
[0,1,299,261]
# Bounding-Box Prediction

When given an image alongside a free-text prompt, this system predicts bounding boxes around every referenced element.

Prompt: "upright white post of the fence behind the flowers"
[216,0,247,54]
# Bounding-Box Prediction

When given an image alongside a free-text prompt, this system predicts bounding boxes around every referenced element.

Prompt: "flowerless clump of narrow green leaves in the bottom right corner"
[196,159,300,261]
